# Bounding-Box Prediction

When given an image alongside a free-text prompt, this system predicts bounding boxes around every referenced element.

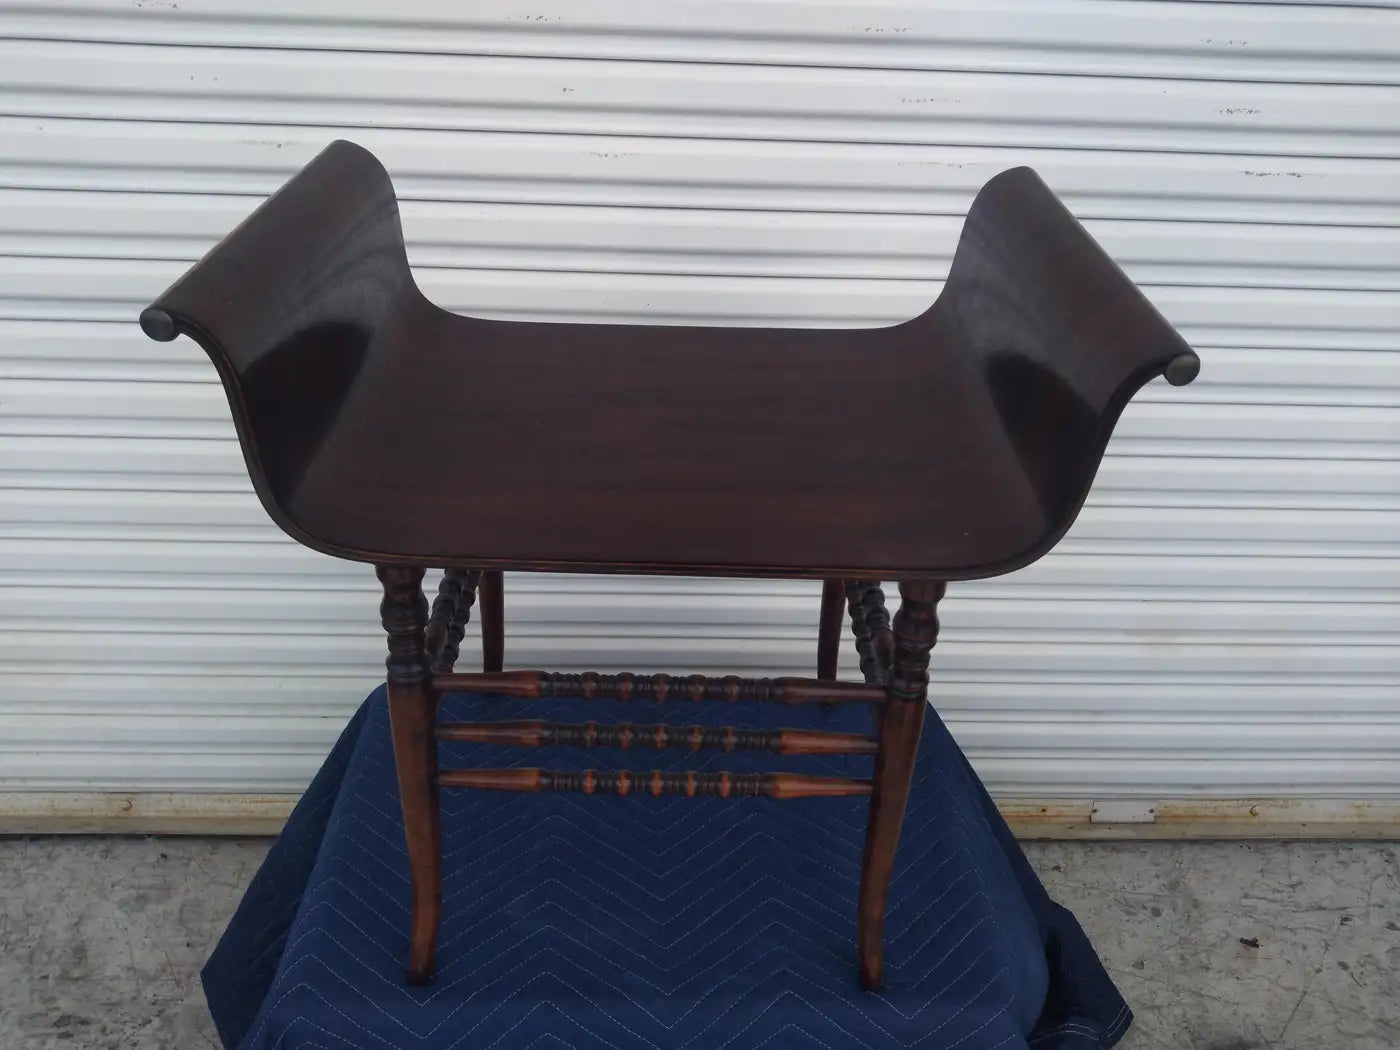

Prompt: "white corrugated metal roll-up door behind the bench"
[0,0,1400,797]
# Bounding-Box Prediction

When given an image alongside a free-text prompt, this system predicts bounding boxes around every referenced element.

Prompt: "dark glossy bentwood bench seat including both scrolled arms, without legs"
[141,141,1200,580]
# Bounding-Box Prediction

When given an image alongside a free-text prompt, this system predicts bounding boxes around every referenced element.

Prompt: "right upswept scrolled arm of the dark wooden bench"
[916,168,1200,571]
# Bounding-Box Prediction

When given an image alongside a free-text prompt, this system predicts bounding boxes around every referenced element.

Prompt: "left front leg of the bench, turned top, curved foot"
[375,566,442,984]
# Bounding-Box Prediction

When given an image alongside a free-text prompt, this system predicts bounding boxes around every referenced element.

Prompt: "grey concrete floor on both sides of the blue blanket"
[0,839,1400,1050]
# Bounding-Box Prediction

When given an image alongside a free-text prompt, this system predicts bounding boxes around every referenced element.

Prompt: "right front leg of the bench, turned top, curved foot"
[857,581,945,991]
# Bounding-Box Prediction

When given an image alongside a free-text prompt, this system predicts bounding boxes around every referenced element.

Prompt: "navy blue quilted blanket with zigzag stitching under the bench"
[206,689,1128,1050]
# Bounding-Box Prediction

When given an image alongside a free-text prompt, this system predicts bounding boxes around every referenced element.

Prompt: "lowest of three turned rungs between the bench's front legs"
[438,769,871,799]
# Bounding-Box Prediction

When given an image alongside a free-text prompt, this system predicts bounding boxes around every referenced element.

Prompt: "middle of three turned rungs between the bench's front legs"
[437,721,876,755]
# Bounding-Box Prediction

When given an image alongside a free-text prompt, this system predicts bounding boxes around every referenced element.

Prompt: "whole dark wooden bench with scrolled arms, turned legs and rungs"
[141,141,1200,988]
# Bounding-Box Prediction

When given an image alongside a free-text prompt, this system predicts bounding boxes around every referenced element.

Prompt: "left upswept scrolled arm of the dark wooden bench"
[140,141,421,542]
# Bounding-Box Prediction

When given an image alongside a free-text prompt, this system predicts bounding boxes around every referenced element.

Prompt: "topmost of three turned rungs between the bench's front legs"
[433,671,885,704]
